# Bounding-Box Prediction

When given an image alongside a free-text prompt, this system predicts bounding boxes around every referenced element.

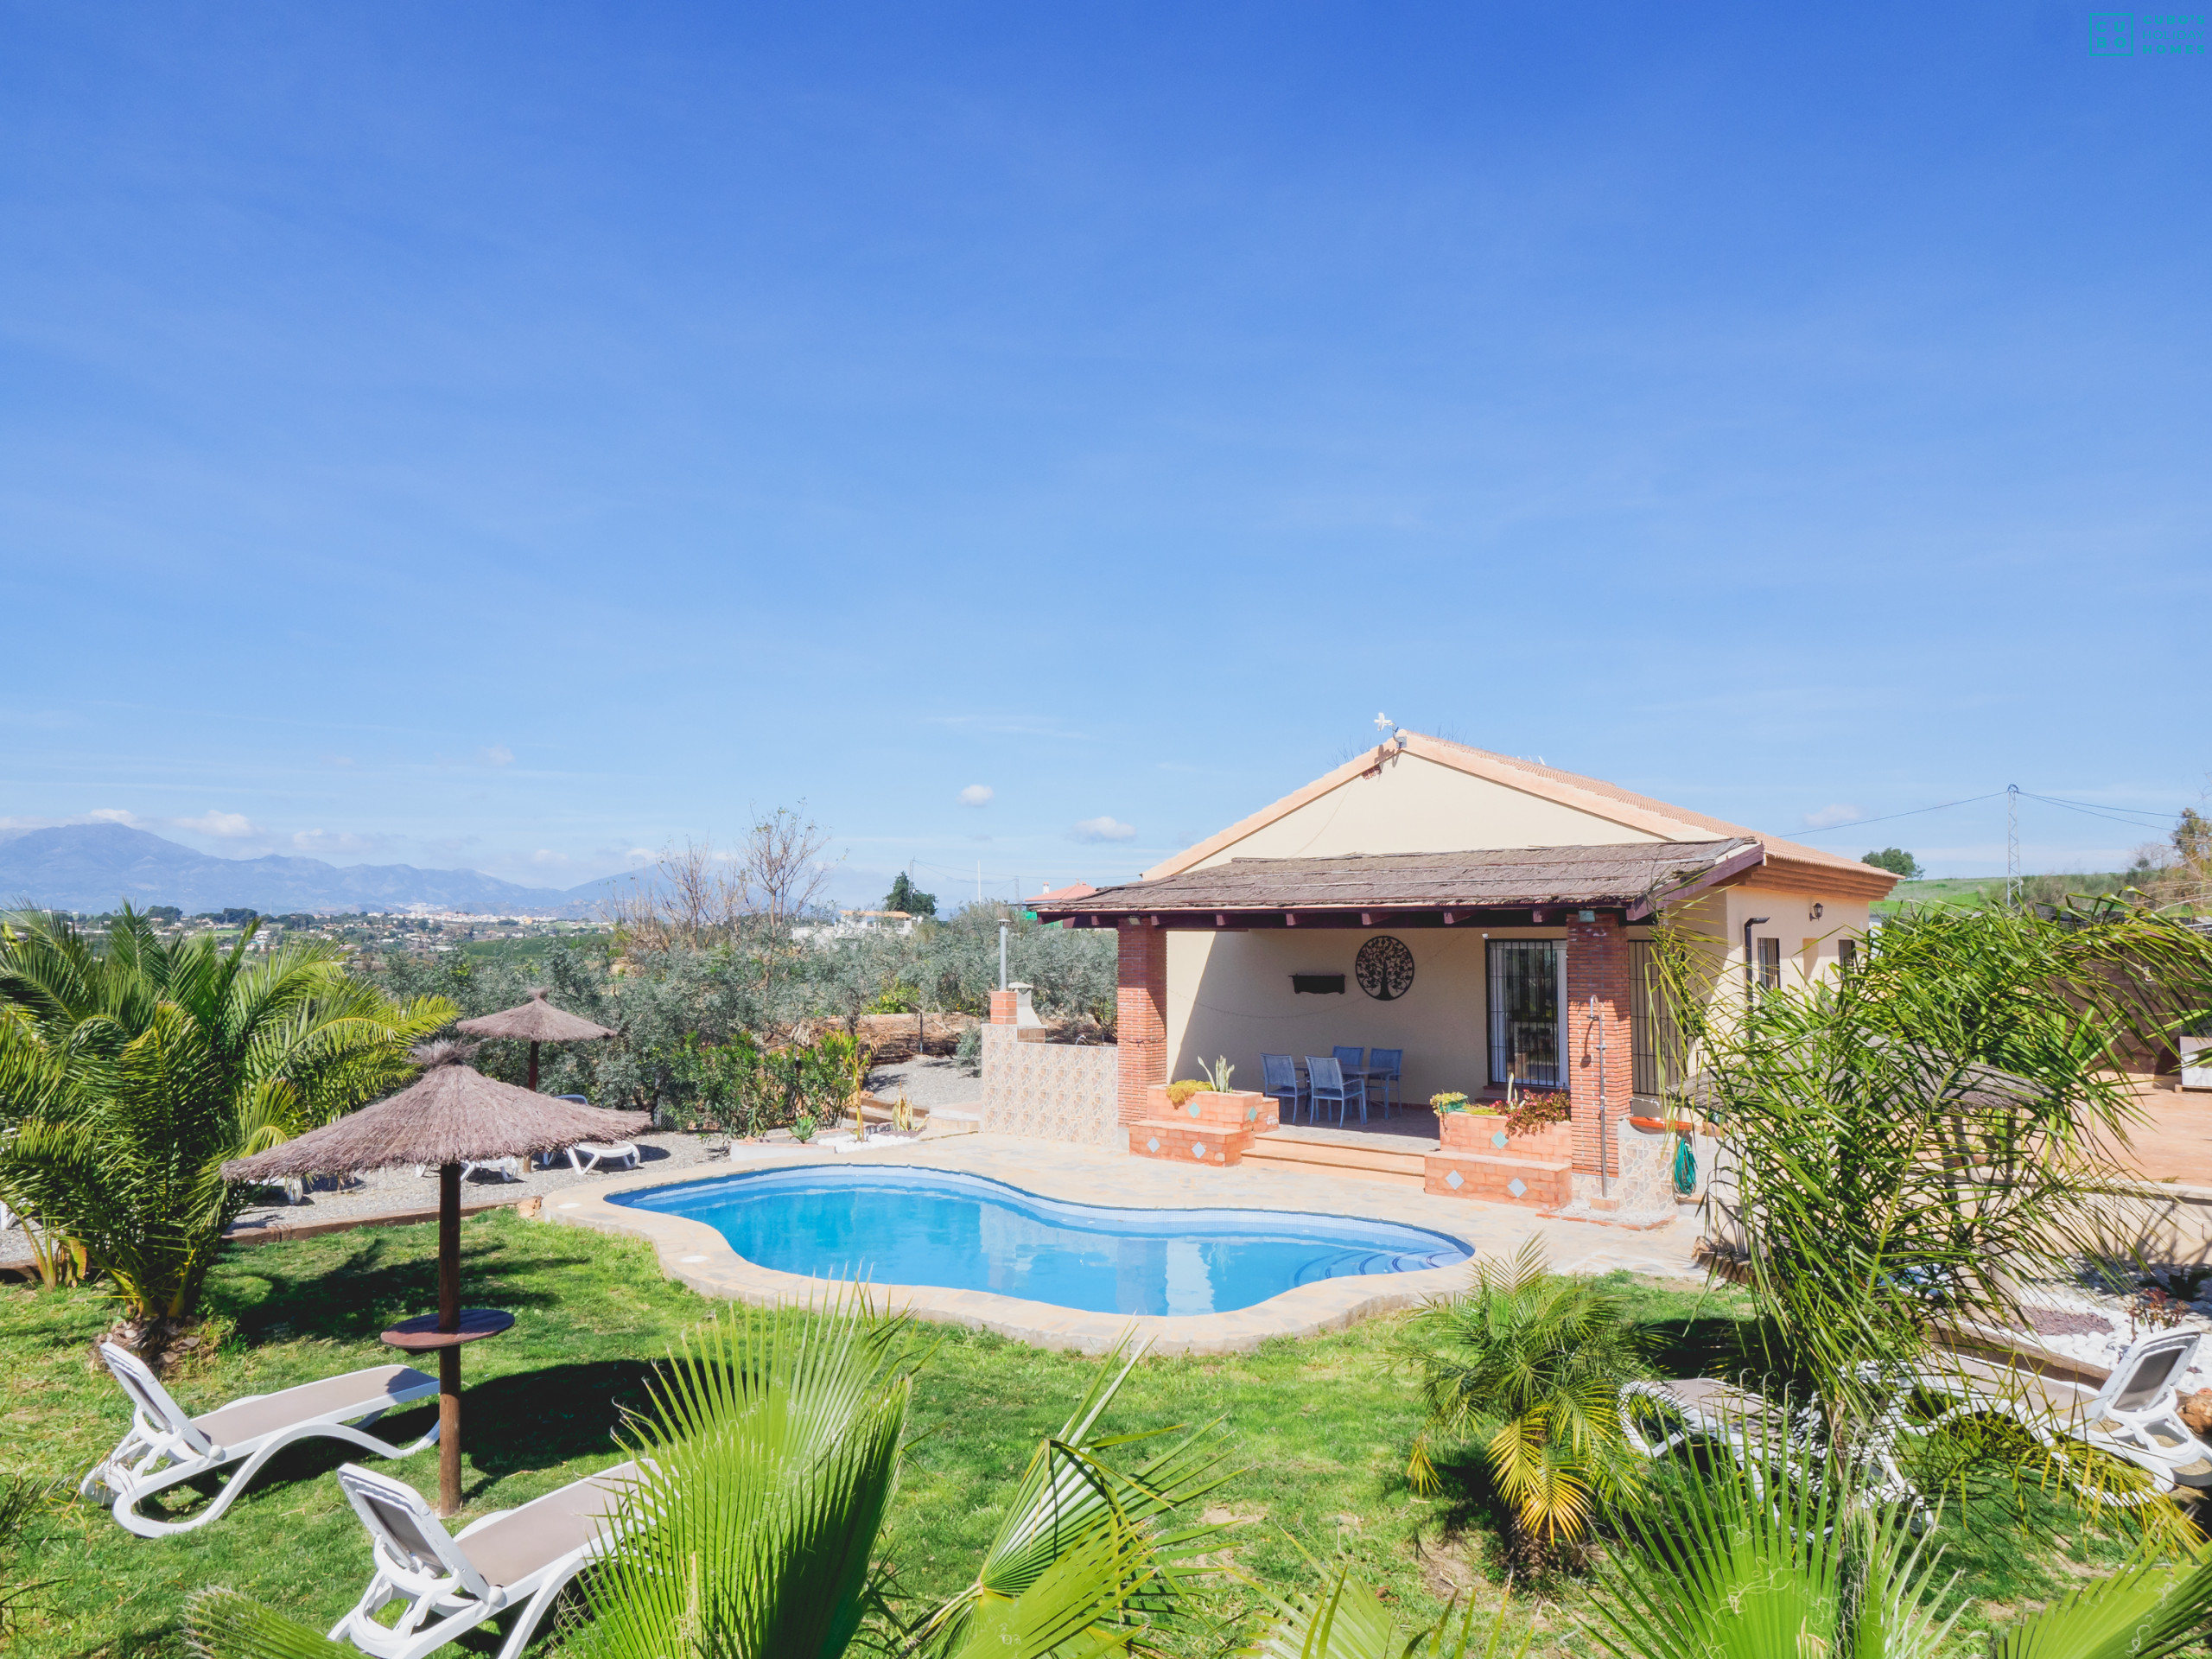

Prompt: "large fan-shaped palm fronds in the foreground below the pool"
[186,1296,1225,1659]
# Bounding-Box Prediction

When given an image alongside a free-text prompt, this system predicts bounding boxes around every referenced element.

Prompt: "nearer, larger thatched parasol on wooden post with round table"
[224,1052,652,1516]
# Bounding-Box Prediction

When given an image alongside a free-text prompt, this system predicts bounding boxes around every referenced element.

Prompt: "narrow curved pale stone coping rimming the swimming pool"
[540,1141,1480,1354]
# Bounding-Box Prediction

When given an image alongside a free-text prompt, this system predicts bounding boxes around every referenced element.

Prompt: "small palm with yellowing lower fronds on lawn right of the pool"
[1391,1239,1646,1560]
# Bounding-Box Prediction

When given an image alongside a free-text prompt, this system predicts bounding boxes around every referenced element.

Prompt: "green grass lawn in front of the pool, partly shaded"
[0,1212,2167,1659]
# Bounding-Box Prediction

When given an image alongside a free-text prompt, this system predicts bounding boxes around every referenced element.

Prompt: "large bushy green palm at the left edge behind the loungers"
[0,907,454,1347]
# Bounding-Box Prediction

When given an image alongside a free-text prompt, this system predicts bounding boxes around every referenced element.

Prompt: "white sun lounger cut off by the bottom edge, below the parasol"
[329,1462,637,1659]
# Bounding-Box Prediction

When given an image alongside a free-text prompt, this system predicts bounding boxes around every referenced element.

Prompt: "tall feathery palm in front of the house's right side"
[1656,900,2212,1513]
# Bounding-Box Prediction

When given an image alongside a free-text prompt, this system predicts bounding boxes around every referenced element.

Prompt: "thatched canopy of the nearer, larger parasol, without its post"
[224,1057,652,1181]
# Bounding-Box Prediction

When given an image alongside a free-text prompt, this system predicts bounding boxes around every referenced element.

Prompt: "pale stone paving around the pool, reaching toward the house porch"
[542,1135,1703,1354]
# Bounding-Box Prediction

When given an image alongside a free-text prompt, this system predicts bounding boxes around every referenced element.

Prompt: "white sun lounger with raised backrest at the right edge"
[1909,1332,2212,1506]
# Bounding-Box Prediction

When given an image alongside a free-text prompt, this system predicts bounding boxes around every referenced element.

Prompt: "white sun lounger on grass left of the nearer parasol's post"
[78,1343,438,1537]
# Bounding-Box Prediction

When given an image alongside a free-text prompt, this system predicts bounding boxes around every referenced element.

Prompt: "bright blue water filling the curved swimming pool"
[608,1164,1471,1314]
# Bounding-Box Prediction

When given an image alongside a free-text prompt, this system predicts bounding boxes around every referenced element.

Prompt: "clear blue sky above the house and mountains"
[0,4,2212,911]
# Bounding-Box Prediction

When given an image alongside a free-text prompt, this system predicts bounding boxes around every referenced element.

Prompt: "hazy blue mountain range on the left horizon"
[0,823,611,916]
